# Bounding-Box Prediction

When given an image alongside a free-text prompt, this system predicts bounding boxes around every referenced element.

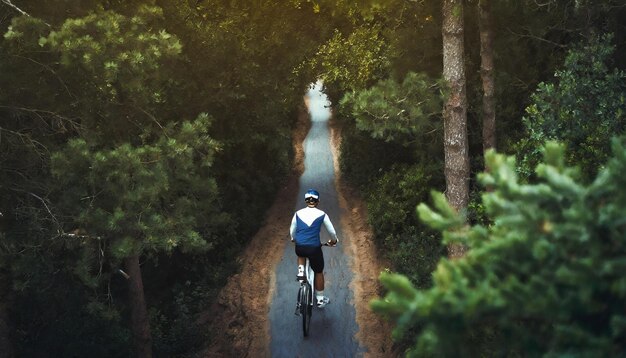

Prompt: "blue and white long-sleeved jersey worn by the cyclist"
[289,207,337,246]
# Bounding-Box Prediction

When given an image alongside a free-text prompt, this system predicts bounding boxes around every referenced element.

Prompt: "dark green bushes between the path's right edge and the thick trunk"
[340,106,444,287]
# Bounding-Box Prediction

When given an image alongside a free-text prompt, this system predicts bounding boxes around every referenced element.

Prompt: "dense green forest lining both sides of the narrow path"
[0,0,626,357]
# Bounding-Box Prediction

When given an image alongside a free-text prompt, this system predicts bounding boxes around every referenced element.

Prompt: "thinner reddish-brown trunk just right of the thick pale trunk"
[478,0,496,151]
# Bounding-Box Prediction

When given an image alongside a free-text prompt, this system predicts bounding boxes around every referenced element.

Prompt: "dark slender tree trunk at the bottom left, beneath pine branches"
[124,255,152,358]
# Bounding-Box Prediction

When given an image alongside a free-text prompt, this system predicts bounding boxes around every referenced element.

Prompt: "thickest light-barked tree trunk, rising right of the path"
[442,0,469,258]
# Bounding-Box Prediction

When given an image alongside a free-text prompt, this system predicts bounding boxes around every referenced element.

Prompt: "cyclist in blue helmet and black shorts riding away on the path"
[289,189,339,308]
